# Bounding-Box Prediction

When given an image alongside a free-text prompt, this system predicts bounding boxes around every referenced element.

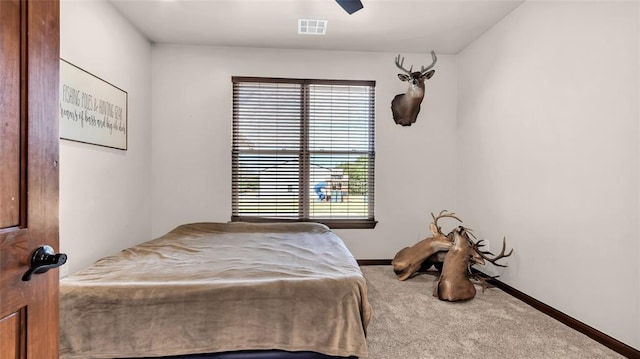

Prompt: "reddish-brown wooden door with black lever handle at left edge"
[0,0,60,359]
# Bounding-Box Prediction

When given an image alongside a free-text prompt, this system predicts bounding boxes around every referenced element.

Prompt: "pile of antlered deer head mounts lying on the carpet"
[391,211,513,301]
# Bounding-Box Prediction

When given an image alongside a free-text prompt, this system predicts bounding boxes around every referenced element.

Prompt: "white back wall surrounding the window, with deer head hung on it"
[152,45,457,258]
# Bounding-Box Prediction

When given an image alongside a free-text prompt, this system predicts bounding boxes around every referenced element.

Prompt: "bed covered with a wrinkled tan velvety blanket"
[60,222,371,359]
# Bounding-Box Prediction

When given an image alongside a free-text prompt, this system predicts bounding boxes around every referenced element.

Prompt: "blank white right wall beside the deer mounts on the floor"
[456,1,640,348]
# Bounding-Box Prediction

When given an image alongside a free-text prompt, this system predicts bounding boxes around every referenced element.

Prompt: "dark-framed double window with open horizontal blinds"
[232,77,376,228]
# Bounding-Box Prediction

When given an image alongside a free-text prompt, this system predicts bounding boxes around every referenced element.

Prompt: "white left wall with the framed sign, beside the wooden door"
[60,0,151,274]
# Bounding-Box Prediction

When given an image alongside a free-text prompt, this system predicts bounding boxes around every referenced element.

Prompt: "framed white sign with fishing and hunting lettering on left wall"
[60,59,128,150]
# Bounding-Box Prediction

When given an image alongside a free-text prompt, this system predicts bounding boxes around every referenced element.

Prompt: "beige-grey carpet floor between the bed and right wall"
[361,266,624,359]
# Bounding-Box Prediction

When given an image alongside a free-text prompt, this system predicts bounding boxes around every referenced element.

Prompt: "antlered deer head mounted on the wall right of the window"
[391,51,438,126]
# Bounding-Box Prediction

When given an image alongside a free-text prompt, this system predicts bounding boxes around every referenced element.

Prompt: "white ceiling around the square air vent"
[110,0,523,54]
